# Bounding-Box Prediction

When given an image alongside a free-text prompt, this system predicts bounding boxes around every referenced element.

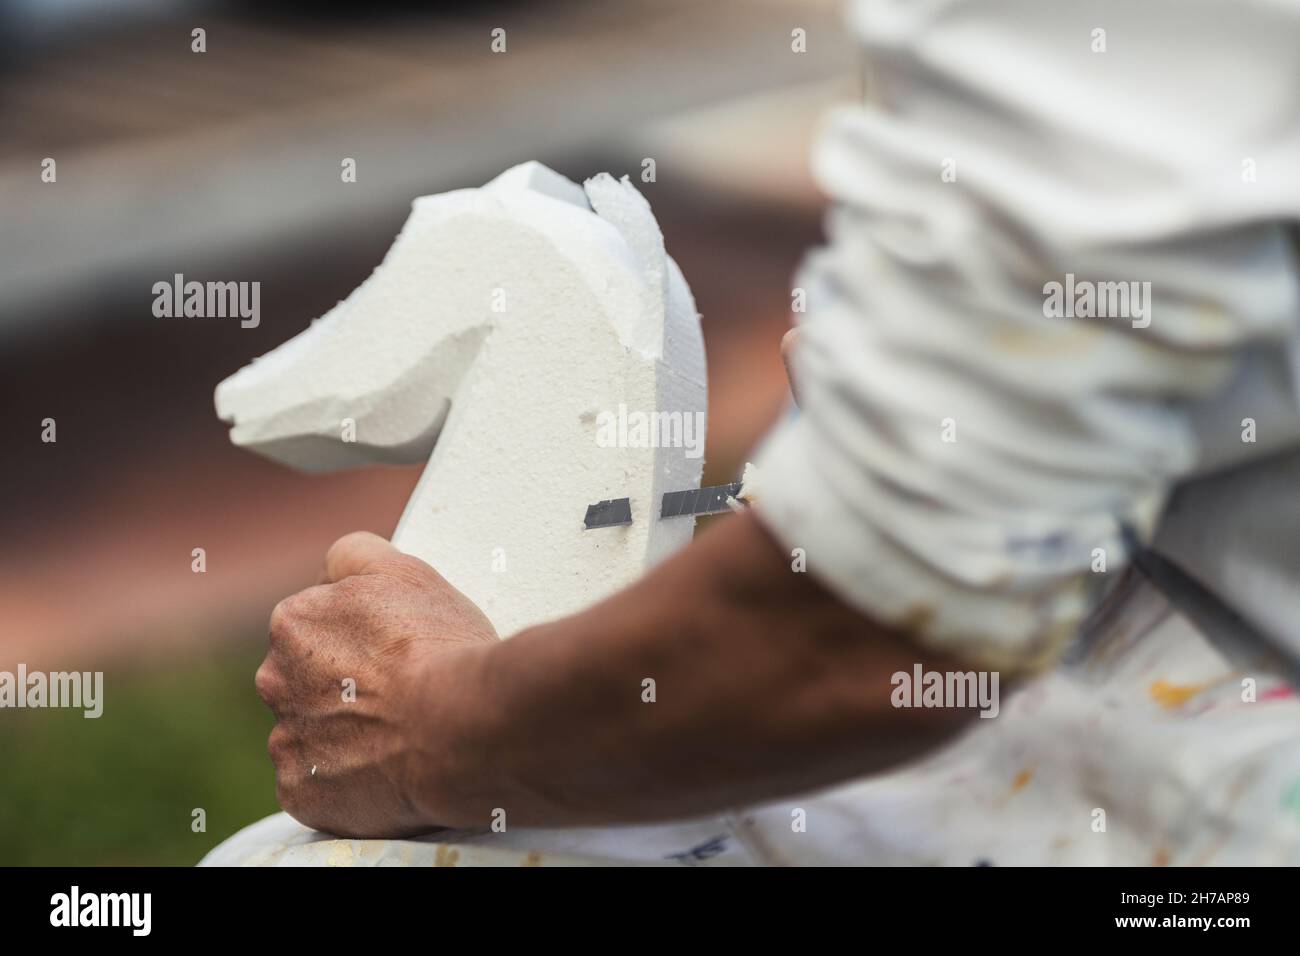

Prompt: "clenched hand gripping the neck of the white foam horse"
[256,532,497,836]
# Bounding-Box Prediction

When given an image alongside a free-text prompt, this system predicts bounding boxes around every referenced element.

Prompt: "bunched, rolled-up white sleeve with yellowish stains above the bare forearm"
[757,0,1300,671]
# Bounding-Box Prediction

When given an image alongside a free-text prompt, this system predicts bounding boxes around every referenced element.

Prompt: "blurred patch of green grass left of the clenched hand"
[0,643,278,865]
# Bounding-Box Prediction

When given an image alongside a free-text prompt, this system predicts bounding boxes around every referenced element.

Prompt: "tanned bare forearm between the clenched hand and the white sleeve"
[420,512,969,826]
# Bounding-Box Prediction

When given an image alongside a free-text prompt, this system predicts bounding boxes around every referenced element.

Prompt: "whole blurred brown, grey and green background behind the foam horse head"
[0,0,859,865]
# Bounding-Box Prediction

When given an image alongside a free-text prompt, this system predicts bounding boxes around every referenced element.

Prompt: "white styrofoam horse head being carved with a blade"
[216,163,706,636]
